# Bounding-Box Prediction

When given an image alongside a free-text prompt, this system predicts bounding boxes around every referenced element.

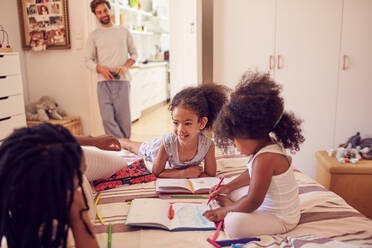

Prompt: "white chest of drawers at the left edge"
[0,53,26,141]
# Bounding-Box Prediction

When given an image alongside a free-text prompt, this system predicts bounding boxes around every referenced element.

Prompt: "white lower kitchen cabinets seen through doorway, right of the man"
[130,63,168,121]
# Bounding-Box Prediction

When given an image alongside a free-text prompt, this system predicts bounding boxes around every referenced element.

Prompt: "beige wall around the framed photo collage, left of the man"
[8,0,100,135]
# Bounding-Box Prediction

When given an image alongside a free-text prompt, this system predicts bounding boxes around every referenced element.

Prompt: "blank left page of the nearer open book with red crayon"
[125,198,170,230]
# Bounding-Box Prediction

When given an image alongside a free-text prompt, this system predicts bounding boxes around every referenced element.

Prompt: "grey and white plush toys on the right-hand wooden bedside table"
[328,132,372,164]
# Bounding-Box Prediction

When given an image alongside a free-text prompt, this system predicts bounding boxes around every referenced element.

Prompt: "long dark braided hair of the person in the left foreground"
[0,124,93,248]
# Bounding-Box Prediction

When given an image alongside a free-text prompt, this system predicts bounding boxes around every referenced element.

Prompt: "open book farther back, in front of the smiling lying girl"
[156,177,220,194]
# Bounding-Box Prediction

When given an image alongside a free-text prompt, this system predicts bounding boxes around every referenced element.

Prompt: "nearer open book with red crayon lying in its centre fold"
[125,198,216,231]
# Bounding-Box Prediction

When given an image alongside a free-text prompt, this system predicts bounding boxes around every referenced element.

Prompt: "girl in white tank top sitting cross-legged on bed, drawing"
[204,73,304,238]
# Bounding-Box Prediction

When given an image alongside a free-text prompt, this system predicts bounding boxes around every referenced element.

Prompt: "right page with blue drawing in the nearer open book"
[171,203,216,230]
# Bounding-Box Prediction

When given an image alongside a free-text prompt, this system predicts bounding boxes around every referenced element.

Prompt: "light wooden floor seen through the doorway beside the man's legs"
[130,104,172,141]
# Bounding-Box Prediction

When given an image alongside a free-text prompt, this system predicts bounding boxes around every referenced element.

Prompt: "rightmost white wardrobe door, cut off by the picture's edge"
[335,0,372,144]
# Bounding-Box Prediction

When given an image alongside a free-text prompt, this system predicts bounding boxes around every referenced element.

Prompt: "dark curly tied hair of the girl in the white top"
[214,72,305,152]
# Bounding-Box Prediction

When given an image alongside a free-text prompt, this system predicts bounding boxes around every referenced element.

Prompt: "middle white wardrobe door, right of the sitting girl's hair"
[275,0,342,177]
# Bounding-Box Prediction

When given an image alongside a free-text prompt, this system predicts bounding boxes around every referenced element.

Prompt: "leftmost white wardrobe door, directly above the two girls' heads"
[213,0,276,87]
